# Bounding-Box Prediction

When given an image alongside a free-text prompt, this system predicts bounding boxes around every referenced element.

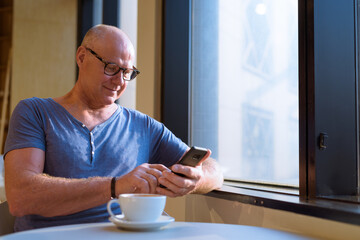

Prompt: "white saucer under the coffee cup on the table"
[109,214,175,231]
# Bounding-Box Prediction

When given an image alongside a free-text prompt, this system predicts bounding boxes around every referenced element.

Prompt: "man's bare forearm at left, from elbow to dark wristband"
[5,174,111,217]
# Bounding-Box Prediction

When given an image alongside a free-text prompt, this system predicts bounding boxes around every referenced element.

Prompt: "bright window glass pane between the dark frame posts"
[190,0,299,186]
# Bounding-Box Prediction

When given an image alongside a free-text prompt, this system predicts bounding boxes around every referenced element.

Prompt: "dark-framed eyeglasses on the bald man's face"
[85,47,140,81]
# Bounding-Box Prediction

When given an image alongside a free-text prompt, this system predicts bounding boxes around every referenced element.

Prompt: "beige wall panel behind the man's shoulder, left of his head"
[11,0,77,110]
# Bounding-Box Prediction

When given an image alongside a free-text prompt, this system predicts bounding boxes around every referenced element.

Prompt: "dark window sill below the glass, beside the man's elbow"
[206,182,360,225]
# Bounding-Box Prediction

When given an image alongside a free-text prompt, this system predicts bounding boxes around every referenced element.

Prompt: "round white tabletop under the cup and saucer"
[0,222,309,240]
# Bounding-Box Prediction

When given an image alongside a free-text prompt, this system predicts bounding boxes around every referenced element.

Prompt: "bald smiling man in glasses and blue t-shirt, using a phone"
[4,25,223,231]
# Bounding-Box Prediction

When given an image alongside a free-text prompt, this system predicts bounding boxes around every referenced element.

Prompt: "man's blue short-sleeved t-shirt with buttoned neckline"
[4,98,188,231]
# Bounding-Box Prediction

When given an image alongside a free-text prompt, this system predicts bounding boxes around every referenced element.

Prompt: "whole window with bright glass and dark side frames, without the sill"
[163,0,359,204]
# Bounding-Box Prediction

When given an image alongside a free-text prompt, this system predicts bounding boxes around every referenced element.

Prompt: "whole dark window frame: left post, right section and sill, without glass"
[162,0,360,225]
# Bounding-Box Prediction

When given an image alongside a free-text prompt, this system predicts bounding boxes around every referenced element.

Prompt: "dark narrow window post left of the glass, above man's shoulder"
[161,0,191,143]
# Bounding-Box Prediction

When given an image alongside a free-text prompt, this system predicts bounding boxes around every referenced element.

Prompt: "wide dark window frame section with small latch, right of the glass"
[299,0,358,199]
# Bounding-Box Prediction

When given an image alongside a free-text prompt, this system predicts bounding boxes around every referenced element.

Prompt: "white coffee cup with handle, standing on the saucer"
[107,193,166,222]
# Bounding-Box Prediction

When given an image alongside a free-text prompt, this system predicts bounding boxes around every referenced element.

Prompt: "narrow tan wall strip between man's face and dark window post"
[136,0,162,121]
